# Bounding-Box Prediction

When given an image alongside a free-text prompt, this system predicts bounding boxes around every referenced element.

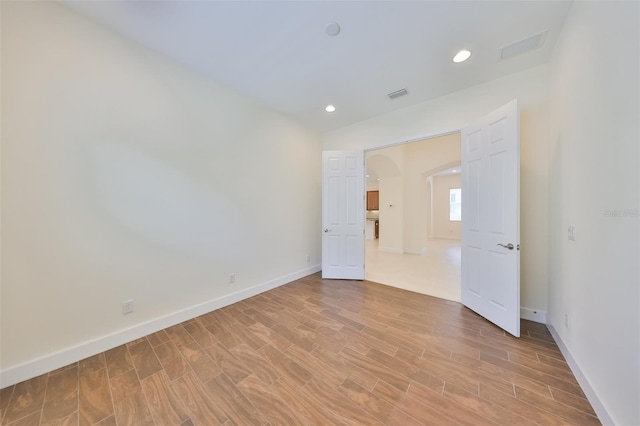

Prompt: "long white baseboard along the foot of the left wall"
[0,265,322,389]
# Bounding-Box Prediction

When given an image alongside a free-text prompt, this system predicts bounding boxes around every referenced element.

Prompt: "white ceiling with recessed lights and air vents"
[63,0,571,132]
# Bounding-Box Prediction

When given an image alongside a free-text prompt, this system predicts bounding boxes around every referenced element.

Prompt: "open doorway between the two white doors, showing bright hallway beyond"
[365,132,461,302]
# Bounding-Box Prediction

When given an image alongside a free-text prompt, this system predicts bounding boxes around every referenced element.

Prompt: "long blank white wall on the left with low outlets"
[1,2,321,386]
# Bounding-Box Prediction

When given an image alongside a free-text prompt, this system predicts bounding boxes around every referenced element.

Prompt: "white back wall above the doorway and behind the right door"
[323,66,549,312]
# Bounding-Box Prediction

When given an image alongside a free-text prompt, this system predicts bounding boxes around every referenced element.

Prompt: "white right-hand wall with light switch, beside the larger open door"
[549,2,640,425]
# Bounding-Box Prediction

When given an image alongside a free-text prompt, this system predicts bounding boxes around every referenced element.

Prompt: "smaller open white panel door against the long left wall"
[322,151,365,280]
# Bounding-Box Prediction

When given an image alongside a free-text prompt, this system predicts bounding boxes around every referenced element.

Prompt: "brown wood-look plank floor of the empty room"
[0,274,600,426]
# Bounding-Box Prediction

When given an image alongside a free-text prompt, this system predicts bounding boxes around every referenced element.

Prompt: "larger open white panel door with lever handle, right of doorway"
[461,100,520,337]
